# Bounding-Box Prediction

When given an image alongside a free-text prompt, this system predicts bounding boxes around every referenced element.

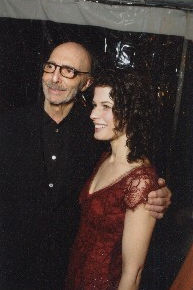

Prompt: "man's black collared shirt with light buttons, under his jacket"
[43,108,77,190]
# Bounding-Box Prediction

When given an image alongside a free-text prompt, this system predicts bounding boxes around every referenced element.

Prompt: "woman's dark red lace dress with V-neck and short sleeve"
[65,157,158,290]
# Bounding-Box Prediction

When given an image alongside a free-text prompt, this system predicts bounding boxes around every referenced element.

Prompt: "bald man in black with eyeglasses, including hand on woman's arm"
[0,42,170,290]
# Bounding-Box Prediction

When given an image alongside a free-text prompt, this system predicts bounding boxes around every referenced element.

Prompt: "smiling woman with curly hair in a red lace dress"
[65,70,159,290]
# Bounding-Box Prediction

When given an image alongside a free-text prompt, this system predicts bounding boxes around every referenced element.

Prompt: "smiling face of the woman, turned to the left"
[90,87,116,141]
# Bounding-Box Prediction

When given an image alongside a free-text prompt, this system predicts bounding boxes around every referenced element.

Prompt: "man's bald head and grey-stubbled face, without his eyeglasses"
[42,42,91,105]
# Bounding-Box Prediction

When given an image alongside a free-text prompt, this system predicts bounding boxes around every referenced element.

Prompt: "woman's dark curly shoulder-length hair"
[93,69,162,163]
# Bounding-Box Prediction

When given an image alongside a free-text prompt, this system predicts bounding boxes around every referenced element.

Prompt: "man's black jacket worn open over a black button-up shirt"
[0,106,102,290]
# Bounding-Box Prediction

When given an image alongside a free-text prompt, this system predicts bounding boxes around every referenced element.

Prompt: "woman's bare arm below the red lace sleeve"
[118,204,156,290]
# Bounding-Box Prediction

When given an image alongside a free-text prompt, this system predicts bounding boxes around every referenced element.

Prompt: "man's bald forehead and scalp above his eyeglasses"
[49,42,91,72]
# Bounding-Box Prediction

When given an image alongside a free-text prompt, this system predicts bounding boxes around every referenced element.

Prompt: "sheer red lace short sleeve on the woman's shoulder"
[124,167,159,209]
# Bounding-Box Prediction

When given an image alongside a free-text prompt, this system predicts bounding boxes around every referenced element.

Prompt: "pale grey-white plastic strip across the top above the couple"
[0,0,193,39]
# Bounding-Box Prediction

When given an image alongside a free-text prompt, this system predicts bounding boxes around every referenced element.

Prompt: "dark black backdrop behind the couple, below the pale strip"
[0,18,193,290]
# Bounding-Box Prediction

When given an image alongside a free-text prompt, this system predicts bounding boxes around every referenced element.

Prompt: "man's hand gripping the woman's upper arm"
[145,178,172,219]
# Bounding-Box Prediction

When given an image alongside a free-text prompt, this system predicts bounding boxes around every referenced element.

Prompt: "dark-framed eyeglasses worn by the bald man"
[43,62,90,79]
